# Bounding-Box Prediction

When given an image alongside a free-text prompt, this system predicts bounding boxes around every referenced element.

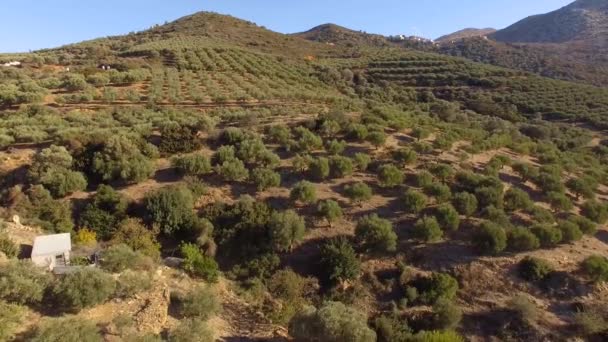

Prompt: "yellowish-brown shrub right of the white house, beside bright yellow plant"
[110,218,160,260]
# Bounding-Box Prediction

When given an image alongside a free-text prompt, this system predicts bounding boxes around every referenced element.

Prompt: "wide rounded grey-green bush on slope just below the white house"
[51,267,116,312]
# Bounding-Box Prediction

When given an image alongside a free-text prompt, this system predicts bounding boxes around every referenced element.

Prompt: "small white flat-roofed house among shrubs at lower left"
[32,233,72,271]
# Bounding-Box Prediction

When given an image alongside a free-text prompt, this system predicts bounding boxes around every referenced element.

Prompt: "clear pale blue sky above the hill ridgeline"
[0,0,572,52]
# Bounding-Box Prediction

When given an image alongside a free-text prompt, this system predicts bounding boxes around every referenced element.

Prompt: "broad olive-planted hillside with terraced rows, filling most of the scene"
[0,8,608,342]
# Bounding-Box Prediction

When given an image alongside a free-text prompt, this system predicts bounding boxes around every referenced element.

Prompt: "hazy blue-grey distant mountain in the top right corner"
[491,0,608,43]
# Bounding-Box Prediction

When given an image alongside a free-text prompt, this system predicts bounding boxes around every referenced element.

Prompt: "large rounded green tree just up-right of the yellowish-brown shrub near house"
[144,186,194,235]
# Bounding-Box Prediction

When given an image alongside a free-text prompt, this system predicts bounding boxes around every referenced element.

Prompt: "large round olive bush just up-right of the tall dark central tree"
[355,214,397,253]
